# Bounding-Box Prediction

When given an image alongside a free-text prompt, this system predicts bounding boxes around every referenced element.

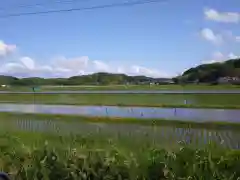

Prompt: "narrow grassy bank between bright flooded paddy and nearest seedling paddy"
[0,113,240,130]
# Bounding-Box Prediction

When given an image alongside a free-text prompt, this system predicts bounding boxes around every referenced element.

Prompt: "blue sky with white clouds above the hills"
[0,0,240,77]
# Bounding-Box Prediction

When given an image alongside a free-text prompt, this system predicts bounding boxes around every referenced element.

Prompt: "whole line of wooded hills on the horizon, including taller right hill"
[0,59,240,86]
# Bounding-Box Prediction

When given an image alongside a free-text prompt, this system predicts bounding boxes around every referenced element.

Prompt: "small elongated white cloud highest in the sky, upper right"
[204,8,240,23]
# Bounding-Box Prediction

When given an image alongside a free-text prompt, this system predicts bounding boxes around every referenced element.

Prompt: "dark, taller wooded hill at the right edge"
[178,59,240,82]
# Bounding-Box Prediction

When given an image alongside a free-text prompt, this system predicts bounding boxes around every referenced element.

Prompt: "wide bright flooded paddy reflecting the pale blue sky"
[0,104,240,122]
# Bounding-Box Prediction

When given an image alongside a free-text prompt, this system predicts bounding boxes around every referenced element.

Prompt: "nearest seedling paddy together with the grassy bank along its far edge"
[0,113,240,149]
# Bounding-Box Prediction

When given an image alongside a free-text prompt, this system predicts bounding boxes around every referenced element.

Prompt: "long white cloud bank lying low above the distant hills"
[0,56,171,77]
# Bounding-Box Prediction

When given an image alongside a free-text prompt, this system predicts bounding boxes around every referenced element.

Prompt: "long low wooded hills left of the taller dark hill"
[0,73,171,86]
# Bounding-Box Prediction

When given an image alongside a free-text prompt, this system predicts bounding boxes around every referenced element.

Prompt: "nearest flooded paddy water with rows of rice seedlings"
[2,120,240,149]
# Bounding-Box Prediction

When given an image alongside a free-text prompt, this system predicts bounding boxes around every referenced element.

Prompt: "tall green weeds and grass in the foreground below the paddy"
[0,132,240,180]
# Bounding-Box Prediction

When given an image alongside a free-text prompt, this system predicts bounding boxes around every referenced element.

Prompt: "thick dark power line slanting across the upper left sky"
[0,0,166,18]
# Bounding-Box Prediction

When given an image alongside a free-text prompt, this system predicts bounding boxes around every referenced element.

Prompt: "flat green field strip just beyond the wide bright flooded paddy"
[0,94,240,109]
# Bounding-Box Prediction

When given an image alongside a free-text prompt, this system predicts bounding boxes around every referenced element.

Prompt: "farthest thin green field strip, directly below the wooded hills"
[0,84,240,91]
